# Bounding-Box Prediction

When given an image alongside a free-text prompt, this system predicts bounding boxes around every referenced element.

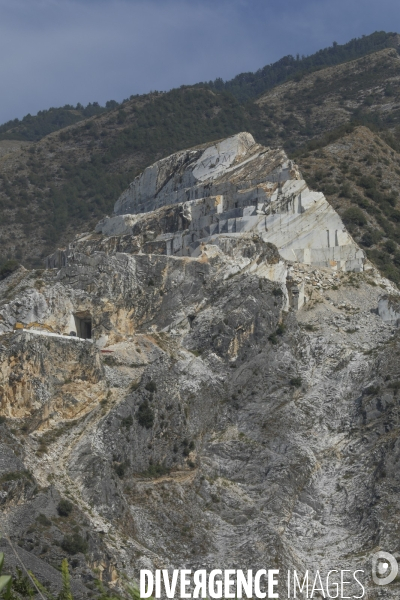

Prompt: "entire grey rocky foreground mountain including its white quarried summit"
[0,134,400,598]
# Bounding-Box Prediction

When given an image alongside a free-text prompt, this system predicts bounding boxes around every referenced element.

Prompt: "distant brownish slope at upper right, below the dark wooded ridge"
[255,49,400,151]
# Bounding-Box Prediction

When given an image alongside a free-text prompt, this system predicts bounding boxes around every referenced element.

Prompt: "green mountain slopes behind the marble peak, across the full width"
[0,34,400,281]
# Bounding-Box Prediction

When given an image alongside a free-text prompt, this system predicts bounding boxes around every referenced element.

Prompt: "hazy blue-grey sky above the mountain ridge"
[0,0,400,123]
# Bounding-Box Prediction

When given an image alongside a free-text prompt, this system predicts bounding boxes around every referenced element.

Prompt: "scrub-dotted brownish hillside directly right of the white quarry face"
[296,122,400,285]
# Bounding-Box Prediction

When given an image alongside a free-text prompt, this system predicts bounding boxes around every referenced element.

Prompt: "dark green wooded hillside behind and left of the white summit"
[0,88,252,267]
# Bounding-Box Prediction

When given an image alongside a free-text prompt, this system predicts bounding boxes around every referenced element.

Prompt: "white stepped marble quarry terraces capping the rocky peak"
[46,133,365,310]
